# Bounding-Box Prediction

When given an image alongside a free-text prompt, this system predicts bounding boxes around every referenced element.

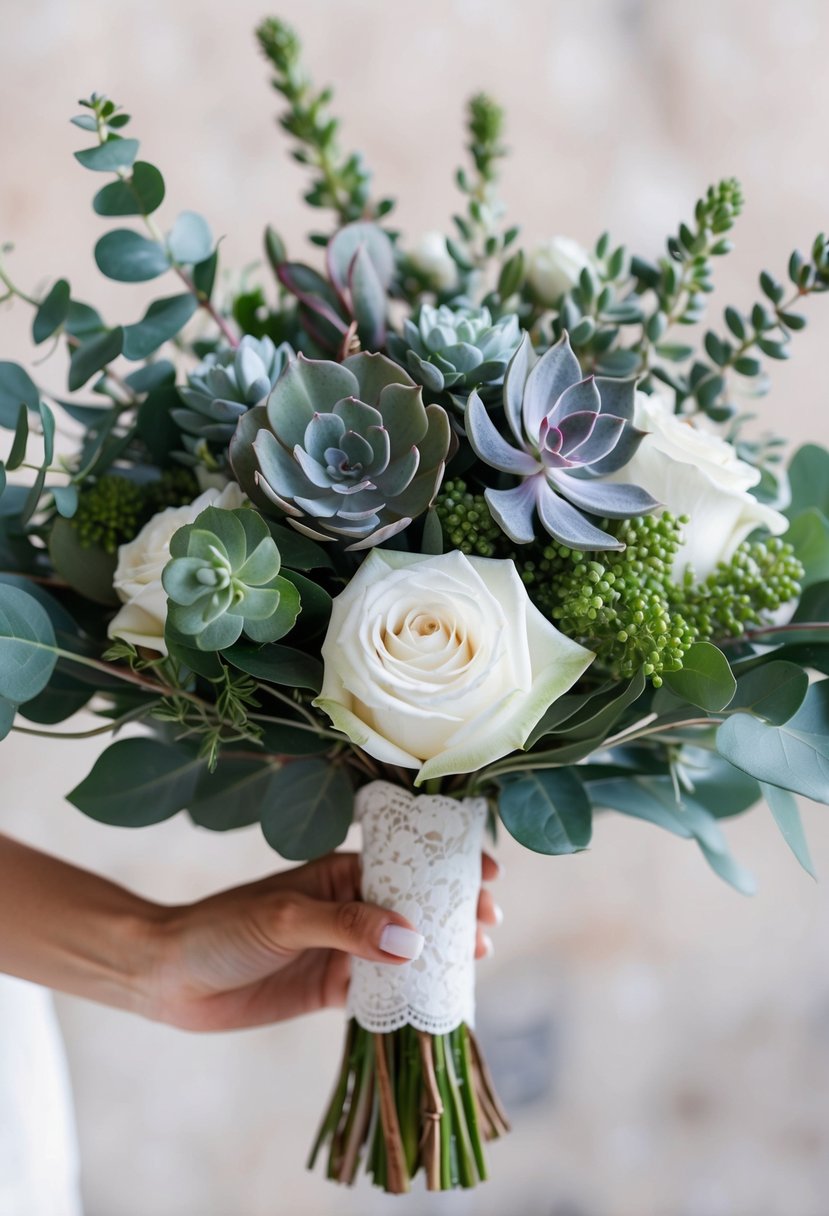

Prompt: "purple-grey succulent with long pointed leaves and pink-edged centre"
[466,334,659,550]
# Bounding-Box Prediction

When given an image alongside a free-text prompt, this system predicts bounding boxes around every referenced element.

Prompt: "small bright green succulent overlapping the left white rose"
[162,507,300,651]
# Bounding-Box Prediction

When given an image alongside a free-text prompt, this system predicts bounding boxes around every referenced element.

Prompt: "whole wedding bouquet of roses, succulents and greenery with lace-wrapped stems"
[0,14,829,1192]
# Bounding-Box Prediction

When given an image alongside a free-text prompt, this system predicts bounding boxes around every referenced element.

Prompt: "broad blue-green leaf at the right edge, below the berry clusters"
[717,680,829,803]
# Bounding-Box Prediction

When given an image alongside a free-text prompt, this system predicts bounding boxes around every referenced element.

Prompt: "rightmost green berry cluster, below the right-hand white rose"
[670,536,803,641]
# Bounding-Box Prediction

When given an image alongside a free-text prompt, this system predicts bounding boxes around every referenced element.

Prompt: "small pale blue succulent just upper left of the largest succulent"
[171,334,293,444]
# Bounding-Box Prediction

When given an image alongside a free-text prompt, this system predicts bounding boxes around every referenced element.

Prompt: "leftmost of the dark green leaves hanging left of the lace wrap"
[67,739,205,828]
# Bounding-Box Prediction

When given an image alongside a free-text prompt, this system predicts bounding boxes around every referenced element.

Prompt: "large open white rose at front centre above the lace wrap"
[315,548,593,784]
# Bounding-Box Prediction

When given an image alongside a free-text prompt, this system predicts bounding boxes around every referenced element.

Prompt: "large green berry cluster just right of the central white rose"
[518,512,697,687]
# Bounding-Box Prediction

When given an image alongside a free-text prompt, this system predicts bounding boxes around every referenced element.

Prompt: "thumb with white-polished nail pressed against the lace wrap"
[271,891,424,963]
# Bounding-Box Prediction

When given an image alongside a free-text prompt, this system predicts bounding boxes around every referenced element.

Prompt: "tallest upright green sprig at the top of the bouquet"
[256,17,394,232]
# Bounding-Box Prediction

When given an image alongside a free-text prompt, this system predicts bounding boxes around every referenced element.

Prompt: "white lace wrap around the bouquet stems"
[349,781,486,1035]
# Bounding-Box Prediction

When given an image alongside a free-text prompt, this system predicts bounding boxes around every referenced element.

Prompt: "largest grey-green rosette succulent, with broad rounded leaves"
[230,353,451,550]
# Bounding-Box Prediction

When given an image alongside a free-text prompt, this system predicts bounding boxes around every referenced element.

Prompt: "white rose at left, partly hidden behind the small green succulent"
[107,482,247,654]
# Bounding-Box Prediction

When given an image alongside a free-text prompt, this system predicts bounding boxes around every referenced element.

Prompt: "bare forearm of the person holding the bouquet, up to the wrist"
[0,835,163,1012]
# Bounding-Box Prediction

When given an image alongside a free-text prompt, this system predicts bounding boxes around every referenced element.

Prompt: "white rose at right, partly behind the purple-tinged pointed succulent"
[605,393,788,581]
